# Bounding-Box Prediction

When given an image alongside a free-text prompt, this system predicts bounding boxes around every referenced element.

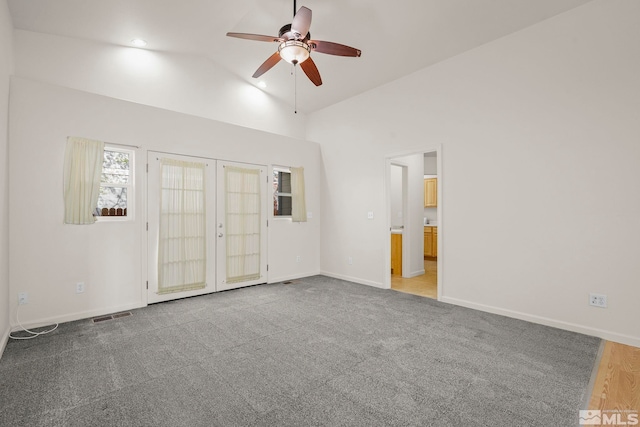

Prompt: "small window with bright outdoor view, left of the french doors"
[94,146,133,219]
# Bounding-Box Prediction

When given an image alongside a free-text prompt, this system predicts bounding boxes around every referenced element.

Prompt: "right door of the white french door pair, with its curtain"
[215,161,268,291]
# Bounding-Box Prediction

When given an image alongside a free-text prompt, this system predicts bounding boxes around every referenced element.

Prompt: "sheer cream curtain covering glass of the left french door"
[158,159,207,294]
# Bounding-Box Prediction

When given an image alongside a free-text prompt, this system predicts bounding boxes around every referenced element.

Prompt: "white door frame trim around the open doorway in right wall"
[380,144,446,301]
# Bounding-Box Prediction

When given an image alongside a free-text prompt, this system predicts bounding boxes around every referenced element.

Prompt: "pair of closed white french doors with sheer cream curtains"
[147,155,268,304]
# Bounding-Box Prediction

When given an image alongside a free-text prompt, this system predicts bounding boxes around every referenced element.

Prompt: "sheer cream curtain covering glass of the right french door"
[224,166,261,283]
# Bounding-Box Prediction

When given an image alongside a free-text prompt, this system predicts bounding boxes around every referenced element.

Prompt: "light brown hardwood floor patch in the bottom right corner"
[588,341,640,425]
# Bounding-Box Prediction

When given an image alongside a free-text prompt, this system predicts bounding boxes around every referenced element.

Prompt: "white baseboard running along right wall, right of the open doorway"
[441,296,640,347]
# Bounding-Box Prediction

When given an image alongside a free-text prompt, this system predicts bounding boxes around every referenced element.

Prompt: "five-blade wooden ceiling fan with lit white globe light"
[227,0,362,86]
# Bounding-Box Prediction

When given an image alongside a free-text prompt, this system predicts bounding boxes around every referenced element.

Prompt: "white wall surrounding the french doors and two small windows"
[9,78,320,325]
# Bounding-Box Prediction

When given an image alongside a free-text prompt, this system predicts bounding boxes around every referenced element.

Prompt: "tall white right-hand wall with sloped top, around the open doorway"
[307,0,640,346]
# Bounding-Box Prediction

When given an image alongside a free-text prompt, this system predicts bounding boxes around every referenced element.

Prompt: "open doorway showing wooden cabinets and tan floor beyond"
[387,149,442,299]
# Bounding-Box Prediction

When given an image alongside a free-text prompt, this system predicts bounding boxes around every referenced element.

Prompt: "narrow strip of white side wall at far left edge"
[0,0,13,356]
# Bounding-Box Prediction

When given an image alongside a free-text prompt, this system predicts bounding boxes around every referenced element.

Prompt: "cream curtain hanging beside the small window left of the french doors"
[64,136,104,224]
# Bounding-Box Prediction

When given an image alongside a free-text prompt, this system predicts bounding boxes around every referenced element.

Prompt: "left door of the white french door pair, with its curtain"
[147,151,216,304]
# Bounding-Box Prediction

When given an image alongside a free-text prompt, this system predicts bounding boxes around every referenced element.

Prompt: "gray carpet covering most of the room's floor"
[0,276,600,427]
